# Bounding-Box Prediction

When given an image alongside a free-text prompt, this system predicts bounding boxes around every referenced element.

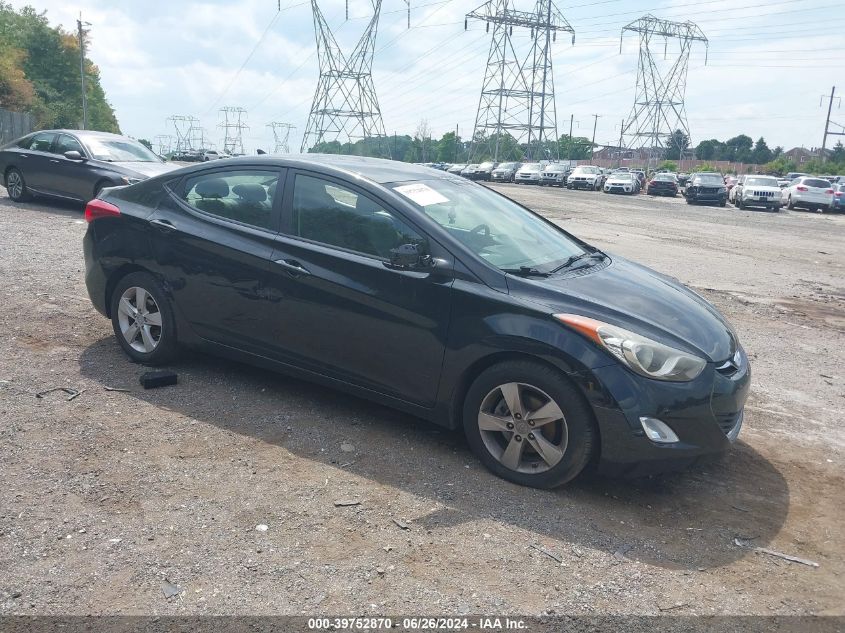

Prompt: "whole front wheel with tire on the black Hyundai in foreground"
[463,361,598,488]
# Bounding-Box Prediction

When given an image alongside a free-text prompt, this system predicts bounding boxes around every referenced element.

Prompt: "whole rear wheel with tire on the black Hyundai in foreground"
[110,272,179,365]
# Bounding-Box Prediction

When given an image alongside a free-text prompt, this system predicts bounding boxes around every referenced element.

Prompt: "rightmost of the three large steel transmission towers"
[619,15,709,163]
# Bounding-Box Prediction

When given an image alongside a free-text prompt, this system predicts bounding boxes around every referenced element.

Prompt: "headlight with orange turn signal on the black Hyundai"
[553,314,707,382]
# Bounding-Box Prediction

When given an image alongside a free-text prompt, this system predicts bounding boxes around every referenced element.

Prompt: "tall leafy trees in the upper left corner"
[0,0,120,132]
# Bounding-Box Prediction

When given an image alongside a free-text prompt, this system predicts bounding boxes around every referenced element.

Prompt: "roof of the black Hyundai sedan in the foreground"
[170,154,465,184]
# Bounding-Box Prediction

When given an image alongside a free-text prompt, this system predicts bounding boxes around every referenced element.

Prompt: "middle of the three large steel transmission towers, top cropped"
[464,0,575,161]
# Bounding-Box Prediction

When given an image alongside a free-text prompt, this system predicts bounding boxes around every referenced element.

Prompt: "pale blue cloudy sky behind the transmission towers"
[12,0,845,153]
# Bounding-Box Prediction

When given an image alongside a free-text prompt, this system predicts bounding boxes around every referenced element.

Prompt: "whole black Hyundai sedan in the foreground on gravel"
[84,155,750,488]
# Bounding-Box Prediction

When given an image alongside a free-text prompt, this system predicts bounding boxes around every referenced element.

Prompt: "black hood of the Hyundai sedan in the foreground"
[508,256,736,362]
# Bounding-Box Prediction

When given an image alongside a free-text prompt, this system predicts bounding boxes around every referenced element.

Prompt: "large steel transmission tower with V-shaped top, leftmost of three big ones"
[302,0,390,158]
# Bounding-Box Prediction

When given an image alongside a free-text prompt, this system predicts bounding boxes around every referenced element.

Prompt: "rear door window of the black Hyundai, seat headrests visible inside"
[180,169,281,230]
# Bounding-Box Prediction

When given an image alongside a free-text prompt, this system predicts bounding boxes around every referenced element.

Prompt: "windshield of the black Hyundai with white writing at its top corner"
[390,180,586,272]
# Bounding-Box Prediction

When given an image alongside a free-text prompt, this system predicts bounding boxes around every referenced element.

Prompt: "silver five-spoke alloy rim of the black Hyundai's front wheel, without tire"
[478,382,569,474]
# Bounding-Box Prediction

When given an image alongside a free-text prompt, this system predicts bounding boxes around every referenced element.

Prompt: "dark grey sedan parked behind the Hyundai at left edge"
[0,130,177,202]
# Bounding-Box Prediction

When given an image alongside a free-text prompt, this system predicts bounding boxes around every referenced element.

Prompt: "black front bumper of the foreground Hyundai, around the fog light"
[582,351,751,475]
